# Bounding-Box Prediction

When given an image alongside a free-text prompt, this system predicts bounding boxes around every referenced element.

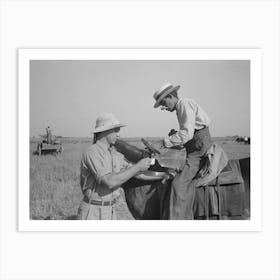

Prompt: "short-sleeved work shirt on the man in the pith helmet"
[80,141,130,201]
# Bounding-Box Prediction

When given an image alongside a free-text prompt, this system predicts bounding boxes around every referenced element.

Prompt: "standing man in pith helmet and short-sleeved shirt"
[78,113,151,220]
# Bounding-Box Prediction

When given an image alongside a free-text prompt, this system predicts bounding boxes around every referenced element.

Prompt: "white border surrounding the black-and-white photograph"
[18,49,262,231]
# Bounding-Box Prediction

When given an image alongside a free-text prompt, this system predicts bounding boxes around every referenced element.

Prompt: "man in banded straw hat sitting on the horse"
[153,83,212,220]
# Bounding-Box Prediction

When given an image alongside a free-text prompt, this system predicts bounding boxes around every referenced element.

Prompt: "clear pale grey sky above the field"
[30,60,250,137]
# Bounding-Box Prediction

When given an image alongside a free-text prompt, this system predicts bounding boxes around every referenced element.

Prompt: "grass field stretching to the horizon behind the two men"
[30,137,250,220]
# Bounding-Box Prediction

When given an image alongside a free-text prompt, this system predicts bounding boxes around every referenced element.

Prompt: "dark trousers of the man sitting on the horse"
[169,127,213,220]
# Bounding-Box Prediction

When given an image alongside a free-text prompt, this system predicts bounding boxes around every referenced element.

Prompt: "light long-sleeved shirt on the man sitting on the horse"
[164,98,210,148]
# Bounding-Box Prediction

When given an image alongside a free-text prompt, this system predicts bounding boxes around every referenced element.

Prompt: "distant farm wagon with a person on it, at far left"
[37,126,63,156]
